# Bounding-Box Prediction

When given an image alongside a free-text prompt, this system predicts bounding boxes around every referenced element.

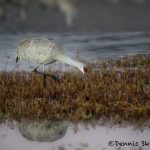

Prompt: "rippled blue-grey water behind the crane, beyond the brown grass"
[0,32,150,71]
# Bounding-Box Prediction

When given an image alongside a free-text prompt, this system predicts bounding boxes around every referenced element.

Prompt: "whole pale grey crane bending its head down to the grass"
[16,37,87,86]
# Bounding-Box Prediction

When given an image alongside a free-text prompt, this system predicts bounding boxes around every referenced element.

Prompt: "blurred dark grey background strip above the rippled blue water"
[0,0,150,33]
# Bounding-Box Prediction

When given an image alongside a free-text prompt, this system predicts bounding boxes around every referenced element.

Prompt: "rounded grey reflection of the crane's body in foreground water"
[17,119,69,142]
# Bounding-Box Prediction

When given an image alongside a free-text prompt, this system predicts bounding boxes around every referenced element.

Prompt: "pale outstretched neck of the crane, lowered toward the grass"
[58,56,84,69]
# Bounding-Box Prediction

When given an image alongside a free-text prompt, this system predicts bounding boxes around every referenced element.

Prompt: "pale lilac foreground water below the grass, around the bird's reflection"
[0,124,150,150]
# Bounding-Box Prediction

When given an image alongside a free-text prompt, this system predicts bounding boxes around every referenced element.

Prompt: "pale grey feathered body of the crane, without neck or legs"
[17,38,64,64]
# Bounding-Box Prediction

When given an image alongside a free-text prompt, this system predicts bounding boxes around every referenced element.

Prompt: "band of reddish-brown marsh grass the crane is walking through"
[0,55,150,122]
